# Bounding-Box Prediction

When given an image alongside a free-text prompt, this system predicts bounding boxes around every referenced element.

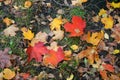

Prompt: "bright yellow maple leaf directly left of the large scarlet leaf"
[50,17,63,30]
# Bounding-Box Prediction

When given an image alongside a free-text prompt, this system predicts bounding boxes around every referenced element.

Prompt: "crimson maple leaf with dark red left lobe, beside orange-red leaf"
[26,42,48,62]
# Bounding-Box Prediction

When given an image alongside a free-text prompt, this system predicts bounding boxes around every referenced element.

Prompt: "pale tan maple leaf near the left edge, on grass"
[3,24,19,36]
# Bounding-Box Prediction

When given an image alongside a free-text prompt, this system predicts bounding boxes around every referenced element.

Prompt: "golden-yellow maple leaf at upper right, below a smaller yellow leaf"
[101,16,114,29]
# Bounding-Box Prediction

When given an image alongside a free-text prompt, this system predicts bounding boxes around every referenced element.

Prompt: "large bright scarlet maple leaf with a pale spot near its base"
[64,16,86,37]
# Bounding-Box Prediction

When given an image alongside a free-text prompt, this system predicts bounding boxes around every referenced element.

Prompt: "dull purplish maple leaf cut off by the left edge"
[0,48,11,68]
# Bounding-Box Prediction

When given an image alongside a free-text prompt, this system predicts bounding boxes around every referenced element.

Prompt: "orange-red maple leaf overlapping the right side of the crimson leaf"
[43,47,64,68]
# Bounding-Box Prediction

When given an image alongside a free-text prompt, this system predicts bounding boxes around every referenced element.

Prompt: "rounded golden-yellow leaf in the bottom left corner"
[3,68,15,79]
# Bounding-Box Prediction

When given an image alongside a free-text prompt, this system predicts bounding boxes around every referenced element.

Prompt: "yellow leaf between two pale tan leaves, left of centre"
[21,27,34,40]
